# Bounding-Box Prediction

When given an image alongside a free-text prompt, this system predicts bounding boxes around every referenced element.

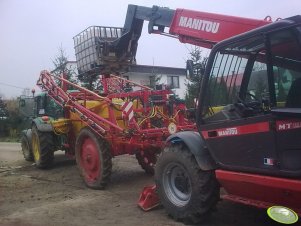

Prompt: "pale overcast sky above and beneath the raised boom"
[0,0,301,98]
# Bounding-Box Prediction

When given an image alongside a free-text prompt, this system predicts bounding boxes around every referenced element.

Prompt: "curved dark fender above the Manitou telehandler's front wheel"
[167,131,217,170]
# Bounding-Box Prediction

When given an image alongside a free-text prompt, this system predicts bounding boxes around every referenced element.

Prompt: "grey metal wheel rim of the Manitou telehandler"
[163,163,191,207]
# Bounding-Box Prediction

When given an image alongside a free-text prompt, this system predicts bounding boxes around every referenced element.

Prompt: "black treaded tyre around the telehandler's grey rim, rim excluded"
[155,143,220,224]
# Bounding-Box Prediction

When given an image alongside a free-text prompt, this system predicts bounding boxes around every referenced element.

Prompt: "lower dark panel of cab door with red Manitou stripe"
[201,115,278,172]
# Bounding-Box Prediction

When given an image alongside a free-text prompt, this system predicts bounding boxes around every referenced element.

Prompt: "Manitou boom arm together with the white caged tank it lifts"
[74,5,271,75]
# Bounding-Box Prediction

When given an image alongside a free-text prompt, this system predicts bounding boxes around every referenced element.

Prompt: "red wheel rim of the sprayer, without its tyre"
[80,137,101,182]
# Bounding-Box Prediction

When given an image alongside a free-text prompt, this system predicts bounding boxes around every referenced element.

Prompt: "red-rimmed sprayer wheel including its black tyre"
[75,128,112,189]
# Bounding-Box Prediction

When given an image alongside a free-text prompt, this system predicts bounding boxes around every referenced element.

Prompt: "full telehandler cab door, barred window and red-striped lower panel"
[199,35,279,174]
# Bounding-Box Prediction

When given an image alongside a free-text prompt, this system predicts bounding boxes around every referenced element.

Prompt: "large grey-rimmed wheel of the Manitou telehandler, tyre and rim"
[155,144,219,224]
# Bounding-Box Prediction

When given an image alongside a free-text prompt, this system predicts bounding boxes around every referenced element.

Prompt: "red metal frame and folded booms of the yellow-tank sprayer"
[37,71,196,156]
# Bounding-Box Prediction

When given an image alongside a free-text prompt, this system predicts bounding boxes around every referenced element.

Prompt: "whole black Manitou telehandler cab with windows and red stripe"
[197,16,301,177]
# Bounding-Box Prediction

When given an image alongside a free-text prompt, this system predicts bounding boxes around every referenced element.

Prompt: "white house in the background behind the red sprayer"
[61,61,187,99]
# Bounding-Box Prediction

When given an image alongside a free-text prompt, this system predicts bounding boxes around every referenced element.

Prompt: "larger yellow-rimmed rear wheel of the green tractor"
[32,126,55,169]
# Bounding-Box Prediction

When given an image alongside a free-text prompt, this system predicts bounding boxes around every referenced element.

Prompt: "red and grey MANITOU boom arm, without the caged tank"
[113,5,271,56]
